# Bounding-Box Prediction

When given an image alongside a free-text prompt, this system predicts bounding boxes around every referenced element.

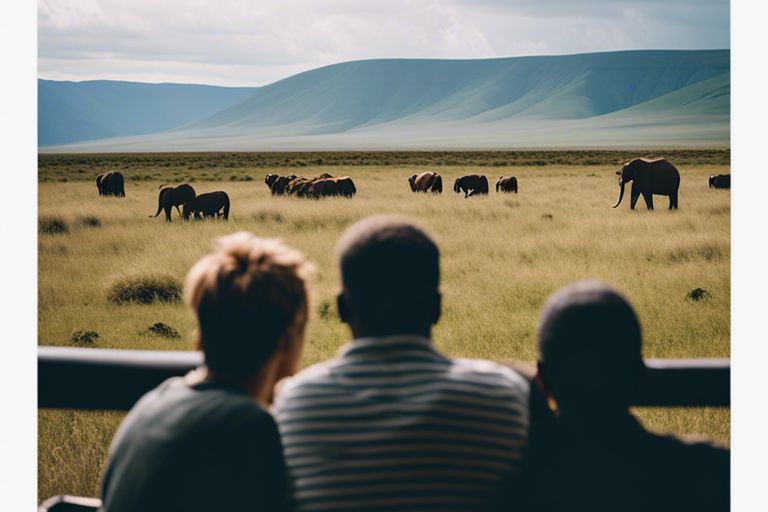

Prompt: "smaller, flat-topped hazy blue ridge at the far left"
[37,79,256,146]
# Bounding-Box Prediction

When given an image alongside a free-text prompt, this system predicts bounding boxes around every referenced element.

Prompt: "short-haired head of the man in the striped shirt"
[337,215,441,338]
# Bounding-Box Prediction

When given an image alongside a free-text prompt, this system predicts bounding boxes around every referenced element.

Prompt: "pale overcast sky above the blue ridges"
[38,0,730,85]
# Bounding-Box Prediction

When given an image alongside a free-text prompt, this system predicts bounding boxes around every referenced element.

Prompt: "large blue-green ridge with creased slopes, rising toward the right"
[40,50,730,151]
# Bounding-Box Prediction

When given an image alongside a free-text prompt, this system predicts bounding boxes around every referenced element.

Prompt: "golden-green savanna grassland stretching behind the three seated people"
[38,150,730,498]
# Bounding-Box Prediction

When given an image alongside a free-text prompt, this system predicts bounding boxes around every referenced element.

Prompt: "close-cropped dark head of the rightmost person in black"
[538,281,643,419]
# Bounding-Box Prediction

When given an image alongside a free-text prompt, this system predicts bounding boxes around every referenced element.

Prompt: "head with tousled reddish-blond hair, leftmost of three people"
[184,231,312,385]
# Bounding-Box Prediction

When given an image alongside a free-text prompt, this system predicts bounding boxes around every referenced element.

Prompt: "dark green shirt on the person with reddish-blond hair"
[102,377,286,512]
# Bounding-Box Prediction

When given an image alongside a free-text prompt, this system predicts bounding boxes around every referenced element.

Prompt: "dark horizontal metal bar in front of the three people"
[37,347,731,411]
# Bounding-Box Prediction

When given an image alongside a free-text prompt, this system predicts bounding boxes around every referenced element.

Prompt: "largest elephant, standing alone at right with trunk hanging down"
[613,158,680,210]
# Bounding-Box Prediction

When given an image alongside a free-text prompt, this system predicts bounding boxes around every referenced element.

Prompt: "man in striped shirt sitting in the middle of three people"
[275,216,528,511]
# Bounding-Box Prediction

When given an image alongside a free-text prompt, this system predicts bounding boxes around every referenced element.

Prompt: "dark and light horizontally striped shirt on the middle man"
[275,336,528,511]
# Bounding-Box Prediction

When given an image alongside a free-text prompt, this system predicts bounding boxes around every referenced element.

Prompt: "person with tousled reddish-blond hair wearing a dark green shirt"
[102,232,311,512]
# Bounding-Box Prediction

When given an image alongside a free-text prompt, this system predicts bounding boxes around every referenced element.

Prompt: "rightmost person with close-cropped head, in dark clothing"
[527,281,730,512]
